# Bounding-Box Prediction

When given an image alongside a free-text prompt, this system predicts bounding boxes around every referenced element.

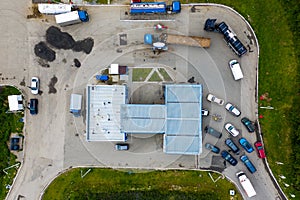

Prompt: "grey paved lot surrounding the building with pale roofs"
[0,0,284,200]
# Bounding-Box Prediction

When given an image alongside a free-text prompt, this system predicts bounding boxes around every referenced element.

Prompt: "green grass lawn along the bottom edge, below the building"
[43,169,242,200]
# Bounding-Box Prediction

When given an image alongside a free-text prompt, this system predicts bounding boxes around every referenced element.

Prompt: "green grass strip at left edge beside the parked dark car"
[0,86,24,199]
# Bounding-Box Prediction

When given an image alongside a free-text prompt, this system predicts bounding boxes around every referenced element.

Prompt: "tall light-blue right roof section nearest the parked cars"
[163,84,202,155]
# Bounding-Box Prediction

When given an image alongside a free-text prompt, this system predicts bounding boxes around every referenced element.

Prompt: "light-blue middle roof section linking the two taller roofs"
[121,104,166,134]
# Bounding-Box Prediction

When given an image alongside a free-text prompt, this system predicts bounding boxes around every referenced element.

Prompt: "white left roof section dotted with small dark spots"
[86,85,127,141]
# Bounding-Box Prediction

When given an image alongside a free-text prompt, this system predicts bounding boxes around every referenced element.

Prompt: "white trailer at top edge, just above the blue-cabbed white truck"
[38,3,72,15]
